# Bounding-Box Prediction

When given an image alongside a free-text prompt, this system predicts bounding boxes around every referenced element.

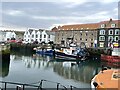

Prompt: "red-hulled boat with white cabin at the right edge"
[101,43,120,64]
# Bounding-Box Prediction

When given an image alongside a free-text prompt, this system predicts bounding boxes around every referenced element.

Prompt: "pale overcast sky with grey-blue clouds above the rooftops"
[0,0,119,29]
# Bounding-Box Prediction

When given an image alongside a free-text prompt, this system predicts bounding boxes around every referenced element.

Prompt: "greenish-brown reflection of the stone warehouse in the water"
[53,62,100,83]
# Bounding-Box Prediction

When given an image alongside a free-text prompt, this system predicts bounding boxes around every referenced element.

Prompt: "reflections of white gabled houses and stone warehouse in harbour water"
[22,55,100,83]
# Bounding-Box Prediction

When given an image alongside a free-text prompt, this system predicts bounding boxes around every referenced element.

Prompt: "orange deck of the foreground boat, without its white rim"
[95,70,120,90]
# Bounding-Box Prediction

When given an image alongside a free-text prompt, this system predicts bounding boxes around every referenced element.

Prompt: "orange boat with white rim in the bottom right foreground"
[91,69,120,90]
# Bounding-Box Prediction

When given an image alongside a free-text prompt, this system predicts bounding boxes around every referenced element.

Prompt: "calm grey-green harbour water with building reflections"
[0,51,101,88]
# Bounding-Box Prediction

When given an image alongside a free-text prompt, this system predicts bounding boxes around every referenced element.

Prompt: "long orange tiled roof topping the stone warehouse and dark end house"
[52,19,120,31]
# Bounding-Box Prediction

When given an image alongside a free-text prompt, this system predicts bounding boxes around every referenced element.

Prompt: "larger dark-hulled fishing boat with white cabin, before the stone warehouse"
[55,47,89,61]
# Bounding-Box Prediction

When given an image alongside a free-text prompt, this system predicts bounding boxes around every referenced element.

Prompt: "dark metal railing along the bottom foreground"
[0,79,80,90]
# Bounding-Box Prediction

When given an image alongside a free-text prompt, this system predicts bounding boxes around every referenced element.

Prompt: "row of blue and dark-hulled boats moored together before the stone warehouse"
[34,43,89,60]
